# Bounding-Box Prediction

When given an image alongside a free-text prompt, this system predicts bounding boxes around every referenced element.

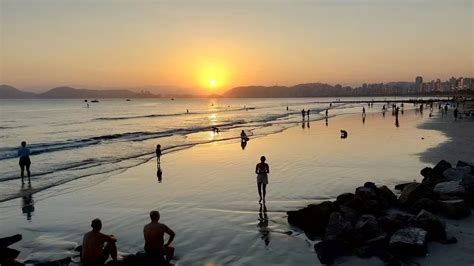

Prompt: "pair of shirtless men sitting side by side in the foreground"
[81,211,175,266]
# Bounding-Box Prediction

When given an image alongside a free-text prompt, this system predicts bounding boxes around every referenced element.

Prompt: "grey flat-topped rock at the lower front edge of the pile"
[389,227,428,256]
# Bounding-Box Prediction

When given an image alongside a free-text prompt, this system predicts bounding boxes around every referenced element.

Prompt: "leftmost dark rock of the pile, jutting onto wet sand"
[287,201,338,240]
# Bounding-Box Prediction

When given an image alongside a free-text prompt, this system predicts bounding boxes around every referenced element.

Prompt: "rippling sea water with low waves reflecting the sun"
[0,95,426,201]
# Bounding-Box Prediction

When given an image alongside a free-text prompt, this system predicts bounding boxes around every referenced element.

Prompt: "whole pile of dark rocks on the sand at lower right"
[287,161,474,265]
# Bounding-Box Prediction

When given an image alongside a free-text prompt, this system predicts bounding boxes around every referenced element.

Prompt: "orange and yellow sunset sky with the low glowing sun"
[0,0,474,93]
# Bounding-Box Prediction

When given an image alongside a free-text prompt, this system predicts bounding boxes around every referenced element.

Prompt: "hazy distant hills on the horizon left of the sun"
[0,85,160,99]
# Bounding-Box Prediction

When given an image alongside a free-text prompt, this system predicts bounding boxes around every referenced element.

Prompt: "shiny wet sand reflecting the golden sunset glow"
[0,111,474,265]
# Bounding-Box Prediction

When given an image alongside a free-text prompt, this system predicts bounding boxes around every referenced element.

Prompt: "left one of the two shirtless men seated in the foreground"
[81,218,117,266]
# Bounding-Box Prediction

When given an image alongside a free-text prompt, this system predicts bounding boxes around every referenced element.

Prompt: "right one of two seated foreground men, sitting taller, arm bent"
[143,211,175,265]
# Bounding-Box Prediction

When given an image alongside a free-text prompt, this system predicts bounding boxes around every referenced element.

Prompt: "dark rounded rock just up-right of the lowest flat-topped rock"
[413,210,446,240]
